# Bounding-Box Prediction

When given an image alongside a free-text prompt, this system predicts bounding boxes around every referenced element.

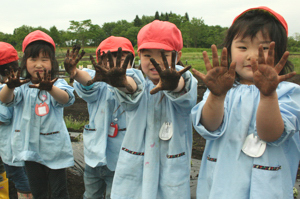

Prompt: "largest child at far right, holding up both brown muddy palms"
[192,7,300,199]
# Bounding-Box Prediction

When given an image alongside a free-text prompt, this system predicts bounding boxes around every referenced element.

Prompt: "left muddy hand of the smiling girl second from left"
[4,66,30,89]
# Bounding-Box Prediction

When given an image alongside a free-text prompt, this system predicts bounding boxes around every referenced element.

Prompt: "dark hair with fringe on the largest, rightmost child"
[224,10,294,82]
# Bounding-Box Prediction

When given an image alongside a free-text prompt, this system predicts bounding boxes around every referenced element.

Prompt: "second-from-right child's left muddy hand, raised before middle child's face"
[107,48,134,93]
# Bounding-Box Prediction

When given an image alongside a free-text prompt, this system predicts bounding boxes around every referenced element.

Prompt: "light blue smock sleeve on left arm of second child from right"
[113,68,145,111]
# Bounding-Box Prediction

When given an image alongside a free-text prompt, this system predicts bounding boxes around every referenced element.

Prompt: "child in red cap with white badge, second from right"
[104,20,197,199]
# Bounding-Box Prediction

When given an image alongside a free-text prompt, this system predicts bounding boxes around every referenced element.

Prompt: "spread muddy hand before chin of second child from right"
[150,49,191,95]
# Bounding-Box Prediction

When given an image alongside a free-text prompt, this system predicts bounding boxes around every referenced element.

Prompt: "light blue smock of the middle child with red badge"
[74,69,126,171]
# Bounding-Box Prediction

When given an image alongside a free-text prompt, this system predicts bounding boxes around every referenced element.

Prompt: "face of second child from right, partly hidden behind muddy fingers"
[138,49,181,85]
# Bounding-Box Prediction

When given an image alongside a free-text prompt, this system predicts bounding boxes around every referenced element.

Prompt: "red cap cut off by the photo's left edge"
[0,42,19,65]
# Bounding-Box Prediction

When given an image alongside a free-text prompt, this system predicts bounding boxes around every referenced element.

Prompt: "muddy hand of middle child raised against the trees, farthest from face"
[64,45,85,79]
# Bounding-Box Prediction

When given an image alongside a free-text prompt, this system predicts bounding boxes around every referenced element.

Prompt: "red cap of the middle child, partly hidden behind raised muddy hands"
[96,36,135,60]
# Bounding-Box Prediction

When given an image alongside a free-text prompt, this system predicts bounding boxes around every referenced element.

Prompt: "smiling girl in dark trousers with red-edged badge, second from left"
[0,30,74,199]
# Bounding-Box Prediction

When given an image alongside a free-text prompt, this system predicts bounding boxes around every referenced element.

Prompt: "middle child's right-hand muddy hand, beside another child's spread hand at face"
[87,50,109,86]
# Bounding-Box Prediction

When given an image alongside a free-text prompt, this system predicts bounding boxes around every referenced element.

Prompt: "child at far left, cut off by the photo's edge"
[0,42,32,198]
